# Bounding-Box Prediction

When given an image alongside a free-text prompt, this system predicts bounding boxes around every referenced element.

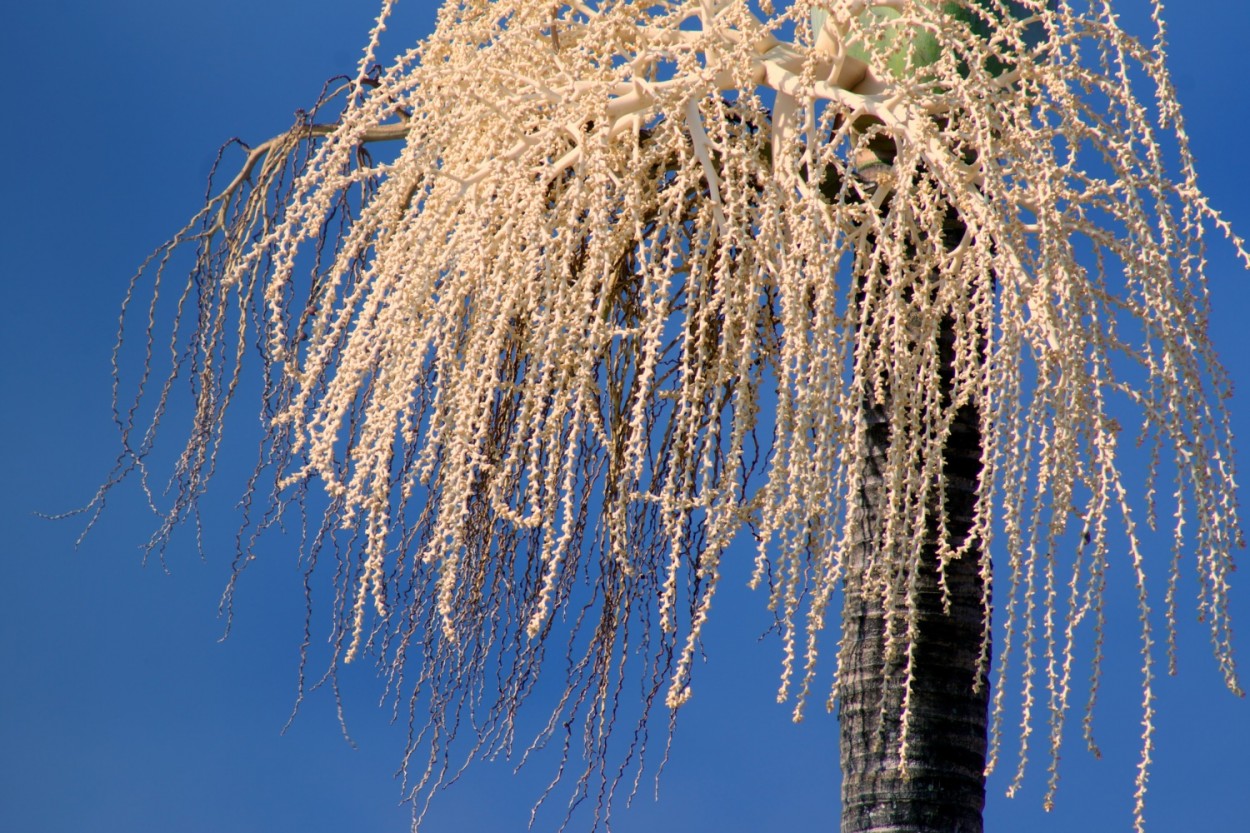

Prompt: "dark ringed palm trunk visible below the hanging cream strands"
[839,287,989,833]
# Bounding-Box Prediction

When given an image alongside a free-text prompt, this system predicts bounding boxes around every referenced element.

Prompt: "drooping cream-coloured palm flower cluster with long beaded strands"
[95,0,1245,825]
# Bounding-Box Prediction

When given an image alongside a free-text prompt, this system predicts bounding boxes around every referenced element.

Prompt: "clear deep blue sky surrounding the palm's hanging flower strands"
[0,0,1250,833]
